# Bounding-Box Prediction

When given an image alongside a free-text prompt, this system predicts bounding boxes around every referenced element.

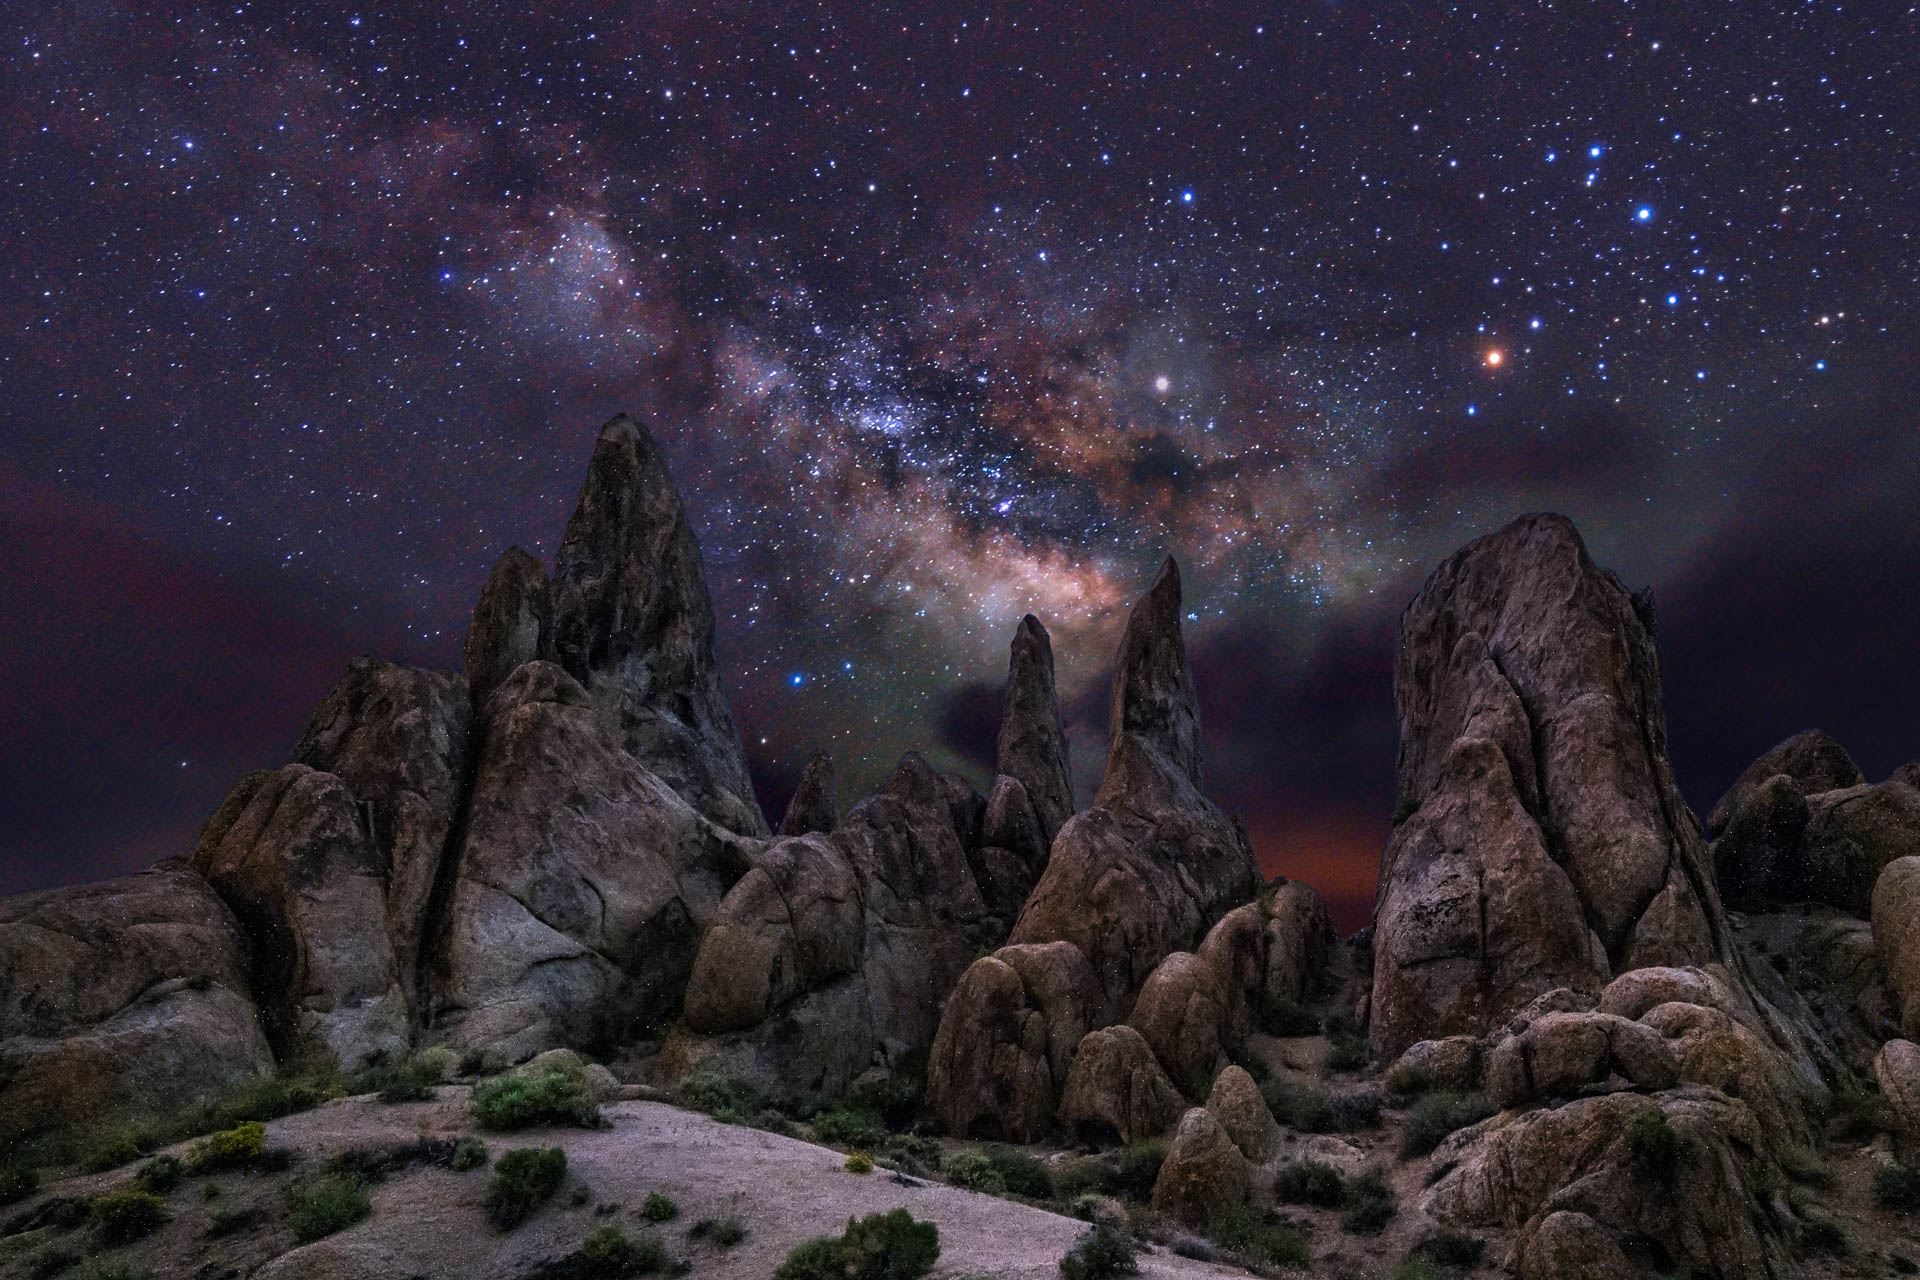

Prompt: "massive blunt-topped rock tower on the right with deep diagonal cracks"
[1371,516,1730,1055]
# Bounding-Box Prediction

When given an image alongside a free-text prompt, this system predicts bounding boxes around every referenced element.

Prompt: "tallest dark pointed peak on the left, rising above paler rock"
[553,415,766,837]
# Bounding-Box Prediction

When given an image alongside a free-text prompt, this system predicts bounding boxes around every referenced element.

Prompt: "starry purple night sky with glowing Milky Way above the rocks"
[0,0,1920,927]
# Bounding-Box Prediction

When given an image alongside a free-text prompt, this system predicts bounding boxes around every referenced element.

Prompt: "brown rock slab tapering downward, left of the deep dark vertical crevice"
[294,656,474,1017]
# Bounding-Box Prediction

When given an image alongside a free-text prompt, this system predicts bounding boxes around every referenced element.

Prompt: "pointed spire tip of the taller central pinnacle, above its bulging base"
[1108,557,1202,791]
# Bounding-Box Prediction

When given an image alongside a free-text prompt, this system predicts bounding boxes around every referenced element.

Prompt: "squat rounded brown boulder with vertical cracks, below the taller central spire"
[927,942,1096,1142]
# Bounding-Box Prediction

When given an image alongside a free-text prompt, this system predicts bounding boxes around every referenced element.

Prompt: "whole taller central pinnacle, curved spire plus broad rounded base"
[1012,560,1260,1023]
